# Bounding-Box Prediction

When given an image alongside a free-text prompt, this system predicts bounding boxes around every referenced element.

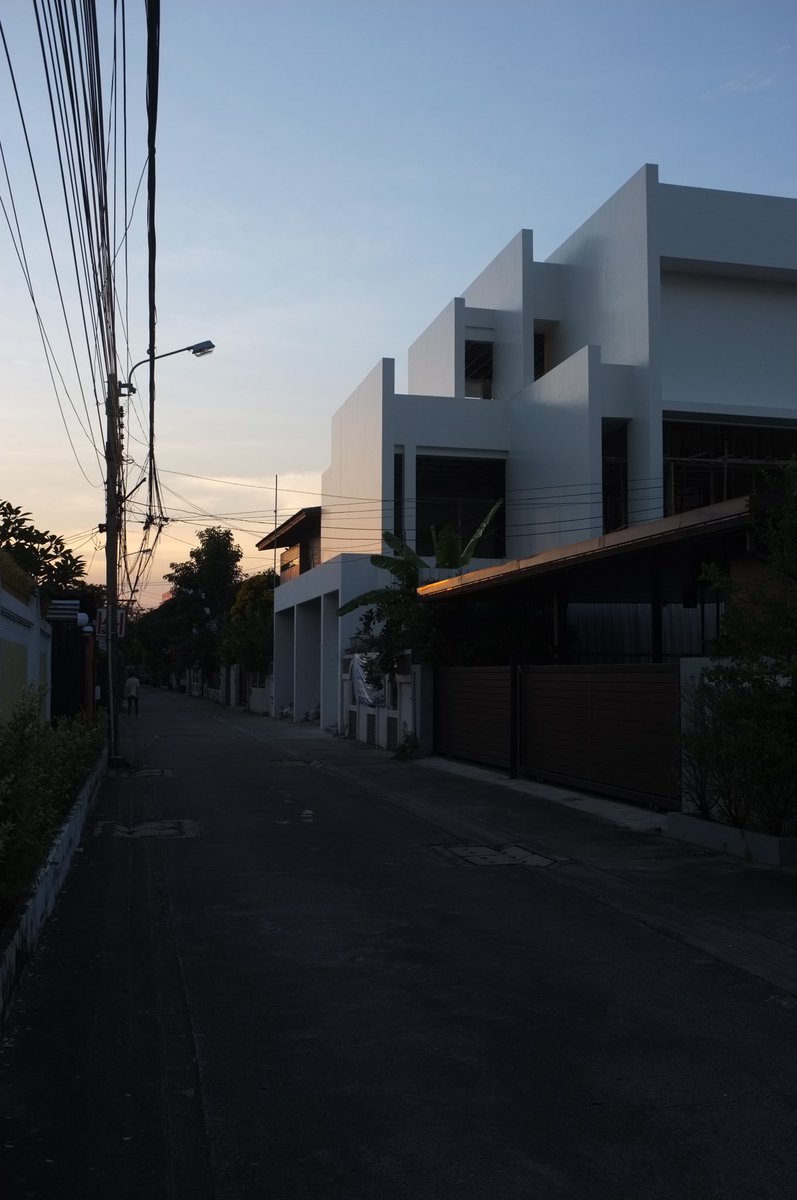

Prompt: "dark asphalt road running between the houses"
[0,691,797,1200]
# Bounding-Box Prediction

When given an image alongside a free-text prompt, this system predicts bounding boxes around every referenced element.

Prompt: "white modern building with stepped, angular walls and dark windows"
[259,164,797,744]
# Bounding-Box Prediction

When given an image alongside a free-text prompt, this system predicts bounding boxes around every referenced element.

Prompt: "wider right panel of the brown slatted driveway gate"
[520,662,681,809]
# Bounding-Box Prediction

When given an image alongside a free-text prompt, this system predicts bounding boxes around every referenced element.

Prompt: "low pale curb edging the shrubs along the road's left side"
[0,750,108,1028]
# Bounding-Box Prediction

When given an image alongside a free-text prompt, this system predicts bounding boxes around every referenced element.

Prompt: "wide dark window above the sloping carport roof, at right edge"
[663,421,797,516]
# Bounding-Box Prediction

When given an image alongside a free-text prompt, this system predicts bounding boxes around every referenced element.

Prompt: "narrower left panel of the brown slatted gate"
[435,667,510,768]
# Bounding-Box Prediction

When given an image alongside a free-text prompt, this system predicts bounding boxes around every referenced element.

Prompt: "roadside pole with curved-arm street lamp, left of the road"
[106,341,216,761]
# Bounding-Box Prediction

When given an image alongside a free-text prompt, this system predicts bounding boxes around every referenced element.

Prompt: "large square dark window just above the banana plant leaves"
[415,455,507,558]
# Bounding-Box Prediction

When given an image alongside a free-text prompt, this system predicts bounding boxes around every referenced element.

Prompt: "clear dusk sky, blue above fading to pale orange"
[0,0,797,607]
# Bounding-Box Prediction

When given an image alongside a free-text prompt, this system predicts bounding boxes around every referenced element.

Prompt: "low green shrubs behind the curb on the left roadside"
[0,689,104,919]
